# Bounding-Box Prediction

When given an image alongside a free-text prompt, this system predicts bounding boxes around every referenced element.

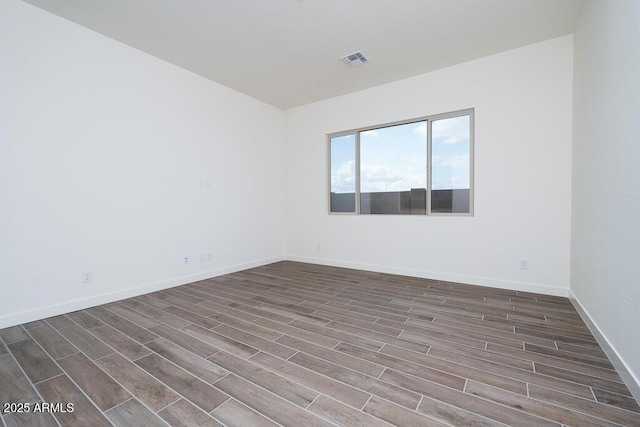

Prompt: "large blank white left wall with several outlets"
[0,0,284,328]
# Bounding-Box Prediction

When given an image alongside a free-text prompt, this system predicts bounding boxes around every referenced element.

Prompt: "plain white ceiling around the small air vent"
[25,0,582,109]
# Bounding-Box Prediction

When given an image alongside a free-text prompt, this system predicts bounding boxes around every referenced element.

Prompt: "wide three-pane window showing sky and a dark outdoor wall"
[329,110,473,215]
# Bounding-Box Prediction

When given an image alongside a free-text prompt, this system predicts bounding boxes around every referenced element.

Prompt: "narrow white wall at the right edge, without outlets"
[571,0,640,400]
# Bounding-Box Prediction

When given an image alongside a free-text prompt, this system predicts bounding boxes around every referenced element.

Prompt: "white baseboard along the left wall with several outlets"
[0,256,284,329]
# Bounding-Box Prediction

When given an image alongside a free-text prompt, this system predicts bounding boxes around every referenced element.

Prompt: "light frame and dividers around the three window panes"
[326,108,475,217]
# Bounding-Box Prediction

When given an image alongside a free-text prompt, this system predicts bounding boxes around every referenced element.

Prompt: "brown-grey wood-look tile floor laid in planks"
[0,262,640,427]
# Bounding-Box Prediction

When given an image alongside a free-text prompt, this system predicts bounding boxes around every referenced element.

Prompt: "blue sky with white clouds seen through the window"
[331,116,470,193]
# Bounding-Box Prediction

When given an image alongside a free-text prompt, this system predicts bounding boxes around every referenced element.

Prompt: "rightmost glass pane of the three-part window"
[431,116,471,213]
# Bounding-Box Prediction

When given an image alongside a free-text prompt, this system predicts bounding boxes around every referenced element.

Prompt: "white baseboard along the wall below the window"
[285,255,569,297]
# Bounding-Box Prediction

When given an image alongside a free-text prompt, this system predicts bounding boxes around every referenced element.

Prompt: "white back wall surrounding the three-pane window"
[285,36,573,296]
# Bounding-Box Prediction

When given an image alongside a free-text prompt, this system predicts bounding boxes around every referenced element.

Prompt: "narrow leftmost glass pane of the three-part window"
[330,134,356,212]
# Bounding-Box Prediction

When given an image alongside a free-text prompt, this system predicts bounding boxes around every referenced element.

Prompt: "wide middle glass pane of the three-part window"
[360,121,427,215]
